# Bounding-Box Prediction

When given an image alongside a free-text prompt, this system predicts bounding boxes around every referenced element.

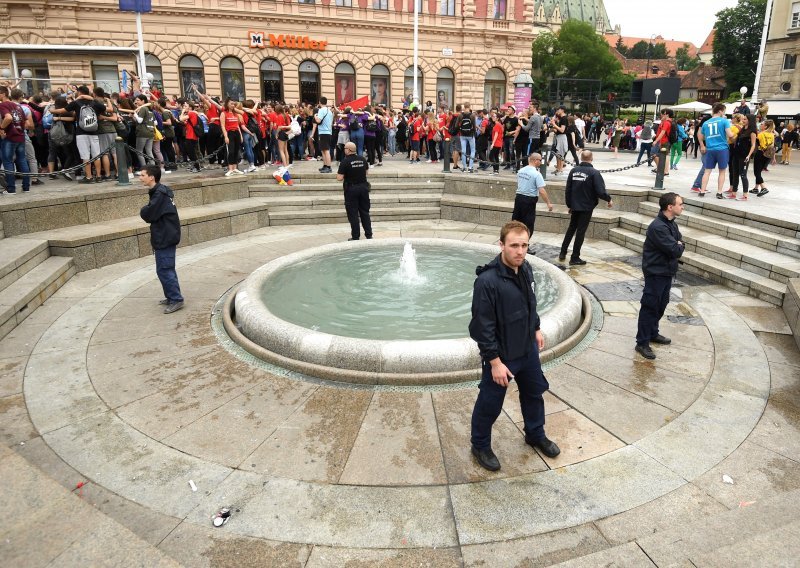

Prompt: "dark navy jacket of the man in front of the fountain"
[469,255,539,361]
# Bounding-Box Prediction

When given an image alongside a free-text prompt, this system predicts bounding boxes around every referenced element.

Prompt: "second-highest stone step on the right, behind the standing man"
[639,201,800,258]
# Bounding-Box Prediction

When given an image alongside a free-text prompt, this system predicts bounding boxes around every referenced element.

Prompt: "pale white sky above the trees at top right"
[603,0,738,47]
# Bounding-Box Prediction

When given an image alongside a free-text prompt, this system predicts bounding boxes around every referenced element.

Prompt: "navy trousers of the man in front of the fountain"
[472,343,550,450]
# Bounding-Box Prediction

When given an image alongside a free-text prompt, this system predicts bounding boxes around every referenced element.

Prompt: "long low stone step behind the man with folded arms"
[22,197,269,272]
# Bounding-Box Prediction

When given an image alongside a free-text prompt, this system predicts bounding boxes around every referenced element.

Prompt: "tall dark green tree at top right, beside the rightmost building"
[712,0,767,96]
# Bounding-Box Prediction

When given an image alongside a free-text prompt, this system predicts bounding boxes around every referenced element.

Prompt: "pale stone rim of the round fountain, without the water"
[225,239,591,384]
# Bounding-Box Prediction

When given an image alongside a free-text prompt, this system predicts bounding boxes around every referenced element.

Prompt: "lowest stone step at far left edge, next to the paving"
[0,256,75,338]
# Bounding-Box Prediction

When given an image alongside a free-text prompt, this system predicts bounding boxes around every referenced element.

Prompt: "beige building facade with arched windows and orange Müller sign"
[0,0,580,107]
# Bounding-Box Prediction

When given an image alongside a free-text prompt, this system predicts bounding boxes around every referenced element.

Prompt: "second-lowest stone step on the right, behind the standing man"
[620,213,800,283]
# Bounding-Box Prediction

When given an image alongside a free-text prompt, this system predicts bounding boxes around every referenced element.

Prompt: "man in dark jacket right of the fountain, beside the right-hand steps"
[636,192,685,359]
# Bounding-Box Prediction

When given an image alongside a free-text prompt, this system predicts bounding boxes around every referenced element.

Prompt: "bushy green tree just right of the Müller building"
[532,20,631,101]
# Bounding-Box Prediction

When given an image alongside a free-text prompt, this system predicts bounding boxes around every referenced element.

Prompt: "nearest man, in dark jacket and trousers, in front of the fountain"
[469,221,561,471]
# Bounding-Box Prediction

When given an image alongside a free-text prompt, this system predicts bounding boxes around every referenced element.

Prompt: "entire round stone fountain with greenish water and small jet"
[225,239,591,385]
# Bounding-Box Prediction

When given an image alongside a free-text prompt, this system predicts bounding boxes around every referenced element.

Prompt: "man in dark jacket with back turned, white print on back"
[558,150,614,266]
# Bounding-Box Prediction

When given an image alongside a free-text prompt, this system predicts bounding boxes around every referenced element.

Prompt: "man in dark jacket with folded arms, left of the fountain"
[139,164,183,314]
